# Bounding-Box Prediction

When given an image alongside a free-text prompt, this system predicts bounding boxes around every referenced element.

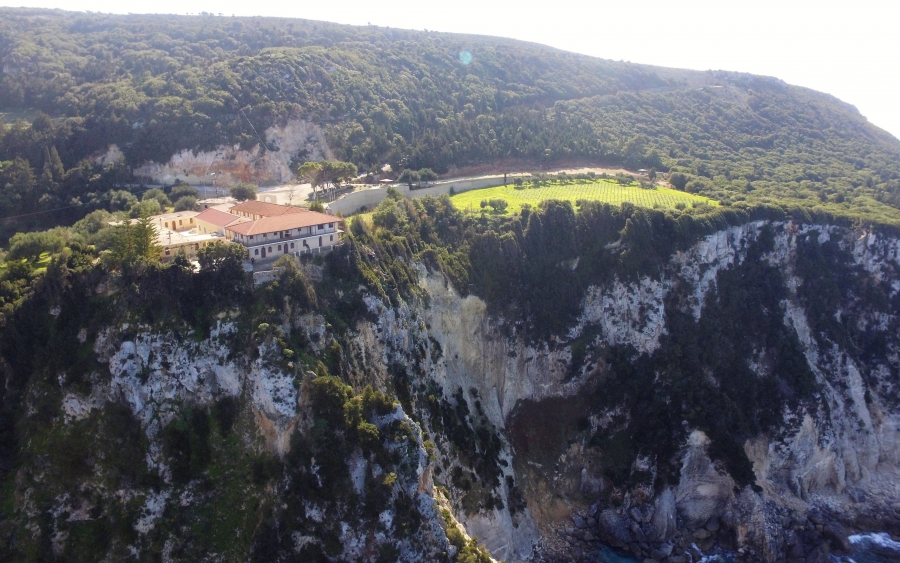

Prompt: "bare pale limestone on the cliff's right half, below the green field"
[346,221,900,561]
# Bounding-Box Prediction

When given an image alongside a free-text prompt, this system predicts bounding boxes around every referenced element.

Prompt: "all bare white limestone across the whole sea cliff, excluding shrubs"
[63,221,900,562]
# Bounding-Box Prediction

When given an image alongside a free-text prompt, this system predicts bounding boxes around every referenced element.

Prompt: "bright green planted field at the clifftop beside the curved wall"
[450,181,719,213]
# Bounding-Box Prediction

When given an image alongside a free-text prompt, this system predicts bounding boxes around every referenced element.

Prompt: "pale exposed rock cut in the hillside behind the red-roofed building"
[119,119,332,187]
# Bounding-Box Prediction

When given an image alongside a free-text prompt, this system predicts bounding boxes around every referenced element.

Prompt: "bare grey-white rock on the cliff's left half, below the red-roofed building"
[67,315,451,563]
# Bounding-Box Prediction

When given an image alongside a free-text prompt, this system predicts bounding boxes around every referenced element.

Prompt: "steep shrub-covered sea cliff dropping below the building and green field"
[0,220,900,563]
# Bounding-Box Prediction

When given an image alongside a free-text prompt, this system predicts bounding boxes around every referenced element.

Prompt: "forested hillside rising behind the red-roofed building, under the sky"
[0,8,900,237]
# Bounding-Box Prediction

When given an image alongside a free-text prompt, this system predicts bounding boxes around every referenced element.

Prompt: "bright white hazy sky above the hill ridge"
[7,0,900,138]
